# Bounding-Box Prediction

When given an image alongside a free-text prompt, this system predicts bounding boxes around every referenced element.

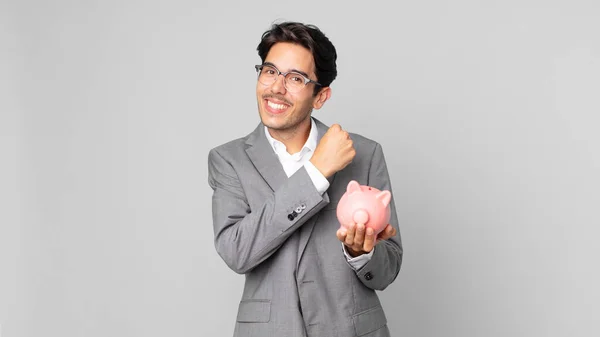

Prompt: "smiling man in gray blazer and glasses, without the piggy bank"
[208,22,402,337]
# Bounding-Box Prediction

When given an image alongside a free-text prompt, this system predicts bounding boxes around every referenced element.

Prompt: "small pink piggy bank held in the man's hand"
[337,180,392,235]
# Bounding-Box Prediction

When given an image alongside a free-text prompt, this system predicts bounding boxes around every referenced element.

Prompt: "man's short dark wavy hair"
[256,22,337,95]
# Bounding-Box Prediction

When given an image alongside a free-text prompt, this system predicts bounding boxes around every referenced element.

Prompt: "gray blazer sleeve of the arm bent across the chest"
[208,149,329,274]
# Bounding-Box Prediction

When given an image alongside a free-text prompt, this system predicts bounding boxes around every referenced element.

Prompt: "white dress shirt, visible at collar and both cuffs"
[265,118,375,270]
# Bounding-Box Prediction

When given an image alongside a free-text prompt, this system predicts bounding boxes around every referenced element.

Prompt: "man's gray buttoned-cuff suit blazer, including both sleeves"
[208,119,402,337]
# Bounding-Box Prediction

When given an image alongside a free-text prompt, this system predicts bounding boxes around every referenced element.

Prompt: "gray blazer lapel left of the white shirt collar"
[246,123,287,191]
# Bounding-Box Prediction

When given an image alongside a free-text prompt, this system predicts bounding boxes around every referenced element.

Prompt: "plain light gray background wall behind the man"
[0,0,600,337]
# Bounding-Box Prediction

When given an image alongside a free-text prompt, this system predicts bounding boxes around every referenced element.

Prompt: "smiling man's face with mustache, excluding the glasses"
[256,42,324,131]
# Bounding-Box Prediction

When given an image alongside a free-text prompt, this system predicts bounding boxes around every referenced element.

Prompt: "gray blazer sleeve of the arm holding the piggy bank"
[356,143,403,290]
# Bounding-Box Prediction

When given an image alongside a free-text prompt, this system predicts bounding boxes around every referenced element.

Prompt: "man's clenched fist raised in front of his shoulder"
[310,124,356,178]
